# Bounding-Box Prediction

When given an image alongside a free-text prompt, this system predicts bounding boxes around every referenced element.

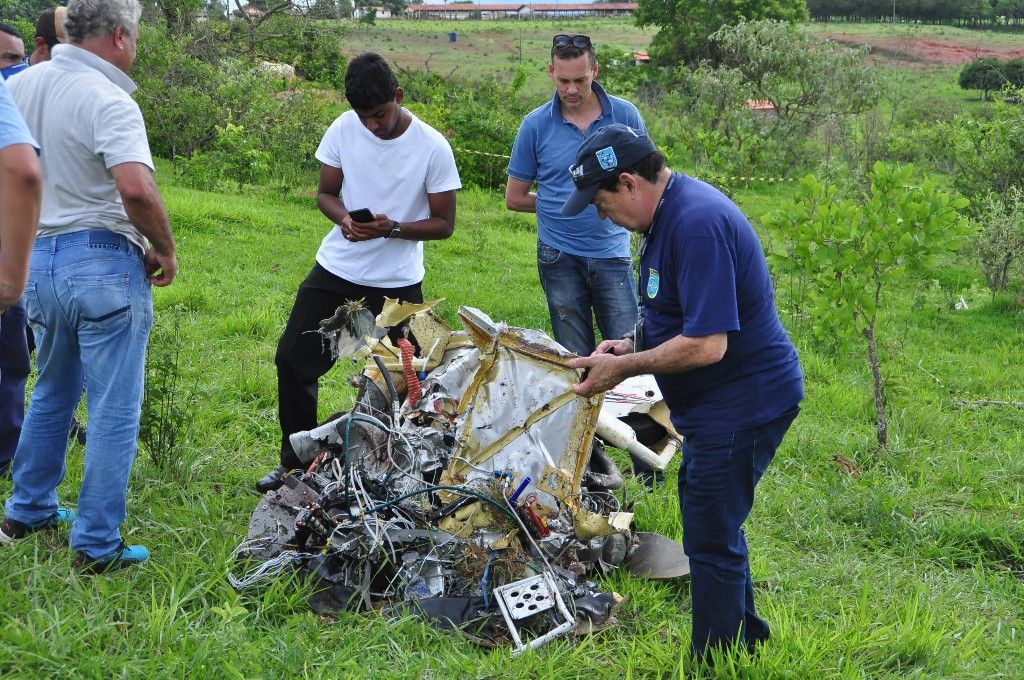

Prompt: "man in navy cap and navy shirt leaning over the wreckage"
[562,125,803,661]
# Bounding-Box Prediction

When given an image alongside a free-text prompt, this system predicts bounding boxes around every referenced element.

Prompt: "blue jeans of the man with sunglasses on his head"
[537,242,637,356]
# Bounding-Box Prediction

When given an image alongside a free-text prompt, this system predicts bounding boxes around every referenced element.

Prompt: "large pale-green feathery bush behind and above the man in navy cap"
[659,22,883,175]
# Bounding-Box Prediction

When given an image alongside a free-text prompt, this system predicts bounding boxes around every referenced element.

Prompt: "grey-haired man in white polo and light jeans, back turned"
[0,0,177,572]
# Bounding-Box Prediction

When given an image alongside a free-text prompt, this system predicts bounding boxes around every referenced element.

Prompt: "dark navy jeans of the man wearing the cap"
[679,407,800,660]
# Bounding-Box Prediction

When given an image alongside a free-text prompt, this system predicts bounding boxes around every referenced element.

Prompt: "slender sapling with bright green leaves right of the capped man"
[767,163,968,449]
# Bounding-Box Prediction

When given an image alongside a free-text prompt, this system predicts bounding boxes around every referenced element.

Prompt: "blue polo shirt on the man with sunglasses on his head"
[508,82,647,257]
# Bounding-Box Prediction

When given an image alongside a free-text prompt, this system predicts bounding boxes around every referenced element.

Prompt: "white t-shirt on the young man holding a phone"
[316,111,462,288]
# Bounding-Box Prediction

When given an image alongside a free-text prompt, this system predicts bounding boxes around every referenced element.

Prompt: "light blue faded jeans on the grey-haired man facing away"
[5,229,153,558]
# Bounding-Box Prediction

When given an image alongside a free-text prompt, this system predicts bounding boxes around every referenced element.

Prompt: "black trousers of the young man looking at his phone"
[274,264,423,468]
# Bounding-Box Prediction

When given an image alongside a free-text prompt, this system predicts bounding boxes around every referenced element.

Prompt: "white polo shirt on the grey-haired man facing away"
[7,45,153,250]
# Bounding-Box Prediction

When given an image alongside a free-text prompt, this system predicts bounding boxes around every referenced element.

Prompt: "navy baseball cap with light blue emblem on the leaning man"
[561,123,657,215]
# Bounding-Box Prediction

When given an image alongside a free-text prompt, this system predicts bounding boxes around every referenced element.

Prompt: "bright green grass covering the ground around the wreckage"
[0,168,1024,678]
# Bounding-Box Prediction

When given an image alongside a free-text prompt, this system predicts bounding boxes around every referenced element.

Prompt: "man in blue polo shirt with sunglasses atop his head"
[505,35,646,356]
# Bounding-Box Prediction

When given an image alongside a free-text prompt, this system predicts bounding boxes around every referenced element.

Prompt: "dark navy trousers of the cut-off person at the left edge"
[0,302,30,470]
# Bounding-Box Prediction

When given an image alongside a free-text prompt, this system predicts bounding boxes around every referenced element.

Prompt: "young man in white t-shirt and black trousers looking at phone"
[256,52,462,492]
